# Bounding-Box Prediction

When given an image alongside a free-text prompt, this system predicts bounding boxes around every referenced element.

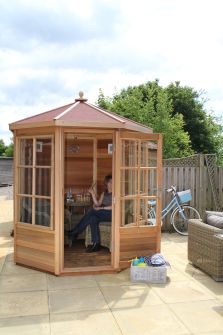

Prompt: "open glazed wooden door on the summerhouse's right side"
[116,132,162,268]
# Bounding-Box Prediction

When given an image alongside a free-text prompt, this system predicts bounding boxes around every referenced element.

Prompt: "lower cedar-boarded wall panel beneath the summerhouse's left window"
[15,225,55,273]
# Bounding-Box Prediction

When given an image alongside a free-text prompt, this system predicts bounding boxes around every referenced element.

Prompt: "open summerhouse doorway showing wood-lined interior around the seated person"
[64,133,112,272]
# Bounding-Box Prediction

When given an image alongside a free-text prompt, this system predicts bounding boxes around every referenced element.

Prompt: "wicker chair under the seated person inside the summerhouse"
[85,222,111,251]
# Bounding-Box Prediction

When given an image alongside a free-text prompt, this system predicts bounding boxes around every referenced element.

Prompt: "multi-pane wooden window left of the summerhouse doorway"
[17,136,53,227]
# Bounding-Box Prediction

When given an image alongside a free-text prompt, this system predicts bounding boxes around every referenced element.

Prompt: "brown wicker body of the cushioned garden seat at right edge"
[188,220,223,281]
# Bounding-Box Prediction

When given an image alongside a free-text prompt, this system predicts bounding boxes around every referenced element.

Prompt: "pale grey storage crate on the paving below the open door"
[130,264,167,284]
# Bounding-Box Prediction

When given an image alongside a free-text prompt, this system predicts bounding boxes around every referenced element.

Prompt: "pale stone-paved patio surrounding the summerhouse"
[0,197,223,335]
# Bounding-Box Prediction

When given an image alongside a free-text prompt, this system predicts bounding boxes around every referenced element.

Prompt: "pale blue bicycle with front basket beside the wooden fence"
[148,186,201,236]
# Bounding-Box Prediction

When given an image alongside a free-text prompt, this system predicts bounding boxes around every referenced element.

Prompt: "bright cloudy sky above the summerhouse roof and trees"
[0,0,223,145]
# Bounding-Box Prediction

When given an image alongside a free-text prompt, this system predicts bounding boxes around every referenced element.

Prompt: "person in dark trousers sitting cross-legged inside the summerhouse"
[67,175,112,252]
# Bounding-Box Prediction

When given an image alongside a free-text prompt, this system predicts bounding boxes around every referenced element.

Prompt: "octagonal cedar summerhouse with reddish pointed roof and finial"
[10,92,162,275]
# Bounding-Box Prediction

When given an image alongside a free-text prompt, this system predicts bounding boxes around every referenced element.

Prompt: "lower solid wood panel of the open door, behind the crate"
[120,227,159,268]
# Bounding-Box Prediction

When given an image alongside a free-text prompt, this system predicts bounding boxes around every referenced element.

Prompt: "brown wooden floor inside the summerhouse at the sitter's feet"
[64,240,111,268]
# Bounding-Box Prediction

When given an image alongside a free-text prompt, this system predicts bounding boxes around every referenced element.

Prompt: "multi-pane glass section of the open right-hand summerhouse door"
[120,138,157,227]
